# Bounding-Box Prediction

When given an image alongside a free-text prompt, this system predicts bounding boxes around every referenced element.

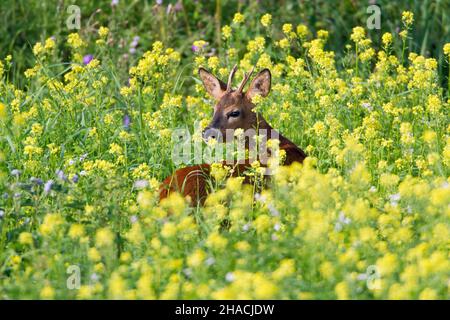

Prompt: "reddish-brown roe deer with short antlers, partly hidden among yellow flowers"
[160,66,306,205]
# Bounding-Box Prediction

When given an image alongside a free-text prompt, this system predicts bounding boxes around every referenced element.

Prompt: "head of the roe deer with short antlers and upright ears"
[199,65,271,137]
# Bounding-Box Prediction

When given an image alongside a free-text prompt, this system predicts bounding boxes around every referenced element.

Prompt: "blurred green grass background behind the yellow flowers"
[0,0,450,87]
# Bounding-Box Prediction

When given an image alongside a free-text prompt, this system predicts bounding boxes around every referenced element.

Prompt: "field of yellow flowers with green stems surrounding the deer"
[0,12,450,299]
